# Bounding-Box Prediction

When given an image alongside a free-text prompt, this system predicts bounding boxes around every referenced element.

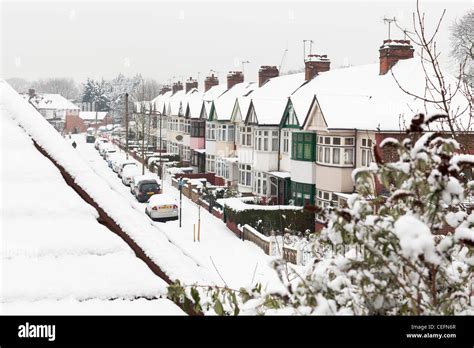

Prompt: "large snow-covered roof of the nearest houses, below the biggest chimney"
[290,57,467,131]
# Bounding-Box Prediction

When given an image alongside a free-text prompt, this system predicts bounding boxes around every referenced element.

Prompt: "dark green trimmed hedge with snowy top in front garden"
[224,205,314,236]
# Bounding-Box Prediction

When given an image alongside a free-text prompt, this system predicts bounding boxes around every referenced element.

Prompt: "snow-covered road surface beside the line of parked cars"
[70,134,281,290]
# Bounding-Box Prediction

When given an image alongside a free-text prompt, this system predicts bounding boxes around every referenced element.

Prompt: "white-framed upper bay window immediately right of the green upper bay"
[316,136,354,166]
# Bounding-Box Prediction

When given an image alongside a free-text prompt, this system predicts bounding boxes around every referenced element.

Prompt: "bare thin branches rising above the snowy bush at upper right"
[391,1,474,150]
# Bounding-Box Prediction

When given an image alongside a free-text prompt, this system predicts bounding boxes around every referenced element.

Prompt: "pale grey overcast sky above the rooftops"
[0,0,473,86]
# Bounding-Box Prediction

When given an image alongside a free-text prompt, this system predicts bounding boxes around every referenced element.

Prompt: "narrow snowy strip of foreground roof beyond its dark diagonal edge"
[0,80,216,290]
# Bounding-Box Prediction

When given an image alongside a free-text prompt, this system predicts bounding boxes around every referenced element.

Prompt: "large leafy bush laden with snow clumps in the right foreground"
[170,118,474,315]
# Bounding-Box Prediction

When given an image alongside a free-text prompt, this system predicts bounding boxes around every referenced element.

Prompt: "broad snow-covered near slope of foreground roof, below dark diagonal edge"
[0,105,183,314]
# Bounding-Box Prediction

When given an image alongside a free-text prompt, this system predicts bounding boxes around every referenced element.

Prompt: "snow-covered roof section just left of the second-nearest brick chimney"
[246,73,305,125]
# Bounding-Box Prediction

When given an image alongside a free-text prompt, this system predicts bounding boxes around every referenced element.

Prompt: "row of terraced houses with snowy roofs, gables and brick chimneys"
[144,40,474,223]
